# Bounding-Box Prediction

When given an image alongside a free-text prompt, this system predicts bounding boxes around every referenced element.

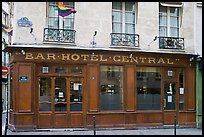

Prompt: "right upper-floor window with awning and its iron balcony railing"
[159,2,184,50]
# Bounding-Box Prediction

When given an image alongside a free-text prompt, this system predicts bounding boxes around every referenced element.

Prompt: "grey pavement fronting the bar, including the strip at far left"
[2,112,202,135]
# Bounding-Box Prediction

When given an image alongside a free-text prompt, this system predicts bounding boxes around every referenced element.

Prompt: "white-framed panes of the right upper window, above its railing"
[159,5,180,37]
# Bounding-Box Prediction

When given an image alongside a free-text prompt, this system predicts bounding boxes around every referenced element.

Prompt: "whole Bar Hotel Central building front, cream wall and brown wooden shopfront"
[4,2,197,130]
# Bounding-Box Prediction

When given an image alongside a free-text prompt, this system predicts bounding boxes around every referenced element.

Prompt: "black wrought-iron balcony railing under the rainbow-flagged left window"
[43,28,76,43]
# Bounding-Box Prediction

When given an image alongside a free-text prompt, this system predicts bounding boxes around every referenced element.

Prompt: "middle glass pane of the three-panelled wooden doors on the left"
[54,78,67,111]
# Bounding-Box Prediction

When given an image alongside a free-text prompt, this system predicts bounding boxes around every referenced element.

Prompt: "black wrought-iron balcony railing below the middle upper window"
[111,33,139,47]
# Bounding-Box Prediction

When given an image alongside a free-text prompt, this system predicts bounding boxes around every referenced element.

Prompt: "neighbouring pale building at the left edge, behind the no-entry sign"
[2,2,13,112]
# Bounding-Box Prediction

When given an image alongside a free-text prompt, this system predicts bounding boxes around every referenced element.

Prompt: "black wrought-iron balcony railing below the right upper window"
[158,37,184,50]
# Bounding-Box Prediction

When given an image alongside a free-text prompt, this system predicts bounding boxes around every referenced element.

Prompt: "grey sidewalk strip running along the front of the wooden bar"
[4,128,202,135]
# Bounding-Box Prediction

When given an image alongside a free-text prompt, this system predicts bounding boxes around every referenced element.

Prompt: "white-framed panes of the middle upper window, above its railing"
[112,2,135,34]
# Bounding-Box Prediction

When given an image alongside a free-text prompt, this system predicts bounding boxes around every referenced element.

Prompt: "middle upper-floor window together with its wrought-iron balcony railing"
[111,2,139,47]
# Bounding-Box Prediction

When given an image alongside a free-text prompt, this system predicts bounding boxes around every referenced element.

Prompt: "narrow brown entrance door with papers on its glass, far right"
[163,81,177,125]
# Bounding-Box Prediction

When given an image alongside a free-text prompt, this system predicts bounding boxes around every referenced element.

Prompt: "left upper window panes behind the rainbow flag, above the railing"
[47,2,74,30]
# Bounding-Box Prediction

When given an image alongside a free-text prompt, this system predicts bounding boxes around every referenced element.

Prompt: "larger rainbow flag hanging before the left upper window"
[58,2,76,17]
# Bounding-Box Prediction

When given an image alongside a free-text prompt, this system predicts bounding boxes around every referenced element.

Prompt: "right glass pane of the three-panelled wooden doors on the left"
[70,77,83,111]
